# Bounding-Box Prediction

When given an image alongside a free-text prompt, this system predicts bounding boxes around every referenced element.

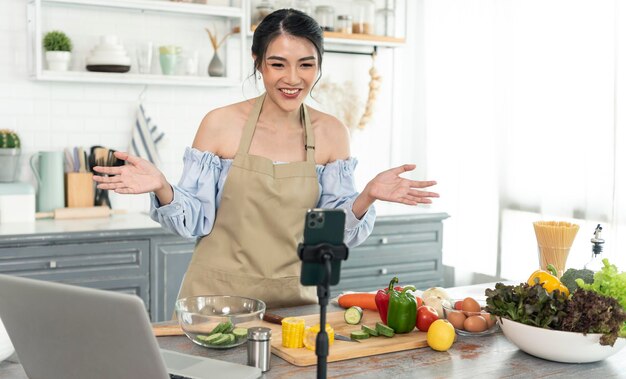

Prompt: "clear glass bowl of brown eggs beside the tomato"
[443,298,498,336]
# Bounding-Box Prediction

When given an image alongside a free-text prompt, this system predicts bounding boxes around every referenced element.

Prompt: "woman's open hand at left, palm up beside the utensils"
[93,151,168,199]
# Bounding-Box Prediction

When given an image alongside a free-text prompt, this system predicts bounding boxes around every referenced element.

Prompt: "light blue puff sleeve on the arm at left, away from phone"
[150,148,232,238]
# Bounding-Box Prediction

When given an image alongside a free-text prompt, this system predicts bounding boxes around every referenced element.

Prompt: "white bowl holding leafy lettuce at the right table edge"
[498,317,626,363]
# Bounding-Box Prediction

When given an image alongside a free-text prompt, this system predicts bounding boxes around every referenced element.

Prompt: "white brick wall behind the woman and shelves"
[0,0,408,211]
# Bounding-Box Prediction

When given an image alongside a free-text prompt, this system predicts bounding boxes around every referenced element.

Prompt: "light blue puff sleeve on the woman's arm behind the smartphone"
[317,158,376,247]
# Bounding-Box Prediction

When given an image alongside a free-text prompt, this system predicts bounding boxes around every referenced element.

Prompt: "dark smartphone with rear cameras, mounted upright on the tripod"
[300,208,346,286]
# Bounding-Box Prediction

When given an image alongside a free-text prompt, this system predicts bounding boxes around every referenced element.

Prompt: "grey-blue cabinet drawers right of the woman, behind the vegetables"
[332,213,448,295]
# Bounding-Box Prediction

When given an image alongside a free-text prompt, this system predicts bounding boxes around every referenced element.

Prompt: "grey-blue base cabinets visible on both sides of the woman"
[0,213,448,321]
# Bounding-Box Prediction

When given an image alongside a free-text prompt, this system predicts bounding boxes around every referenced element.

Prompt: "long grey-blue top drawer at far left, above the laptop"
[0,240,150,281]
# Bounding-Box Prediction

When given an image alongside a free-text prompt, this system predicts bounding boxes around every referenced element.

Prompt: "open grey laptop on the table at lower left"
[0,275,261,379]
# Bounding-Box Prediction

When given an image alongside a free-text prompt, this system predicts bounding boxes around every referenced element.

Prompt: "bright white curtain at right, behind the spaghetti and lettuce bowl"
[423,0,626,279]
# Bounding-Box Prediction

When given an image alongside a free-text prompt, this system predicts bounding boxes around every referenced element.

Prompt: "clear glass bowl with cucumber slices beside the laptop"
[175,295,265,349]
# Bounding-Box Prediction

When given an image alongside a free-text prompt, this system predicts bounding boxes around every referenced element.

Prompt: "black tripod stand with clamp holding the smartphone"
[298,243,348,379]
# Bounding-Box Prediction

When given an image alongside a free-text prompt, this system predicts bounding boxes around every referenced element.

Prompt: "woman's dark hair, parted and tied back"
[252,9,324,76]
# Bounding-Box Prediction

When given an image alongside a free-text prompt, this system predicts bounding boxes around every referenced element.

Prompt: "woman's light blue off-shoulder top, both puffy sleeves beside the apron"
[150,147,376,247]
